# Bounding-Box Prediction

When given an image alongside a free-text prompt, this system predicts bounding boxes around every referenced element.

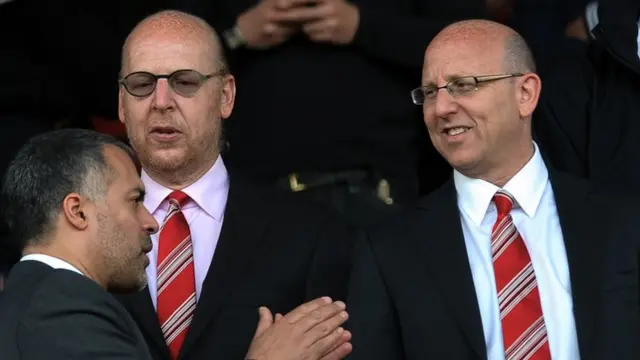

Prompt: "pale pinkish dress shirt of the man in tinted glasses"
[141,156,229,308]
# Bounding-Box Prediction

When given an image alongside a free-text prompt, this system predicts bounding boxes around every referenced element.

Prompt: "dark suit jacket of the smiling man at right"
[347,172,640,360]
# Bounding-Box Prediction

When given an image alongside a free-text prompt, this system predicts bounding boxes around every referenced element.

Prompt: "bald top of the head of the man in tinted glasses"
[121,10,228,75]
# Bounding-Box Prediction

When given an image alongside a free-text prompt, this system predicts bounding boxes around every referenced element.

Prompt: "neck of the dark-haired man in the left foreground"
[22,240,107,289]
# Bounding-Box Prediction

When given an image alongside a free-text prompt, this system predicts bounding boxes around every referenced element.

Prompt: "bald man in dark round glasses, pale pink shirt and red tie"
[119,11,352,359]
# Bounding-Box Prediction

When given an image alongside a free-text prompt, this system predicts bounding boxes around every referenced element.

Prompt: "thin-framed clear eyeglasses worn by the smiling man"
[411,73,524,105]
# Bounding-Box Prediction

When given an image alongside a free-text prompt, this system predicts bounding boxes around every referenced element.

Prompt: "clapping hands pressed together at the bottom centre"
[246,298,351,360]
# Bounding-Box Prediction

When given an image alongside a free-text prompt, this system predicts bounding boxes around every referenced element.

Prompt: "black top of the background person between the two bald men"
[186,0,484,180]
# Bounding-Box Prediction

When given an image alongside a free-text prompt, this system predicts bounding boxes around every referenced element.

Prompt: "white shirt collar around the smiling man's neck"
[453,142,549,226]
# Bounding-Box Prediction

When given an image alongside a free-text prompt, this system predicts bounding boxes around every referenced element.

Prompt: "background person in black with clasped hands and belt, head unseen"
[178,0,485,225]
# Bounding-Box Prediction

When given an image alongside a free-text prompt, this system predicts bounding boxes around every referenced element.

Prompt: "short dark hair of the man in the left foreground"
[0,129,134,251]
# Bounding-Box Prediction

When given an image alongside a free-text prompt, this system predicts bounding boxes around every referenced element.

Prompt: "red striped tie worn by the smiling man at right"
[491,191,551,360]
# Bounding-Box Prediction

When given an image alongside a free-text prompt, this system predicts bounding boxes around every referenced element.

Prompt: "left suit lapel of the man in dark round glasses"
[119,287,171,359]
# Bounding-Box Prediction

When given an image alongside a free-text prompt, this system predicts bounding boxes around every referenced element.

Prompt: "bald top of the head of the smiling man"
[425,20,536,73]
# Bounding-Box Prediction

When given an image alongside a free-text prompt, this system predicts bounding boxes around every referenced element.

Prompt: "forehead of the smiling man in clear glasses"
[422,38,503,85]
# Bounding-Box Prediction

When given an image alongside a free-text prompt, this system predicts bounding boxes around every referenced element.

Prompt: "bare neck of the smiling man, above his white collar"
[458,141,535,188]
